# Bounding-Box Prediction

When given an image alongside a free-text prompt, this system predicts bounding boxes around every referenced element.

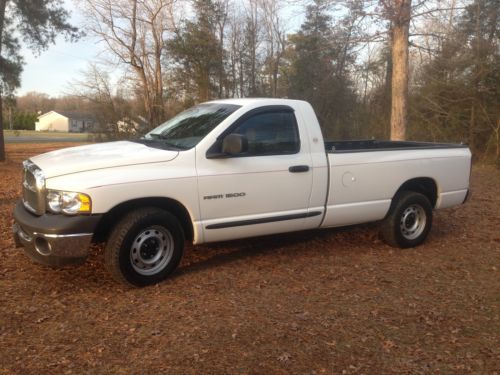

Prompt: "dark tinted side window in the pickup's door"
[232,111,300,156]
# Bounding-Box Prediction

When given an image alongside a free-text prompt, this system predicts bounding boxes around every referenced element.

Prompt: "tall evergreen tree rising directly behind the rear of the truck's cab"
[288,0,356,138]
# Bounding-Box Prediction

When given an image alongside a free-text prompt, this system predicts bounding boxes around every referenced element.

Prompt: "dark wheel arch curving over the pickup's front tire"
[94,197,194,242]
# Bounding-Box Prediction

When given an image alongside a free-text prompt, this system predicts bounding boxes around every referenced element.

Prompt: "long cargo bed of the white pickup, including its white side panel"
[322,140,471,227]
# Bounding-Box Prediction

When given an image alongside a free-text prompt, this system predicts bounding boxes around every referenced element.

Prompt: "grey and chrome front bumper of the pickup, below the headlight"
[12,202,101,267]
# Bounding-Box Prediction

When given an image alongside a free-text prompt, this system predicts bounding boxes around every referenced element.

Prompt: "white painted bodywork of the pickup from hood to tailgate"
[28,99,471,243]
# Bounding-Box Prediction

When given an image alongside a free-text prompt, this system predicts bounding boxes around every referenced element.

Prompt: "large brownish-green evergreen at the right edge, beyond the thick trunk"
[411,0,500,160]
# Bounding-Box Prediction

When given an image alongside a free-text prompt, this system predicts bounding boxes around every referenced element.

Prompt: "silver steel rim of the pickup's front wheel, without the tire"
[130,226,174,276]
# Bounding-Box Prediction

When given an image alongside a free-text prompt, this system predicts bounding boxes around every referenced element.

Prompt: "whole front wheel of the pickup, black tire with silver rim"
[104,207,184,287]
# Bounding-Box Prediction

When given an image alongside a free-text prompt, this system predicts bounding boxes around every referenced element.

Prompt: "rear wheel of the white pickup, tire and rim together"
[381,191,432,248]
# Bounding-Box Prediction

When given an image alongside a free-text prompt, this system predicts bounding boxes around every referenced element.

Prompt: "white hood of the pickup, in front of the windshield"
[30,141,179,178]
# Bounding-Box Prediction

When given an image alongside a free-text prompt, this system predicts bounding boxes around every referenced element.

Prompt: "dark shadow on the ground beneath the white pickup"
[25,219,449,291]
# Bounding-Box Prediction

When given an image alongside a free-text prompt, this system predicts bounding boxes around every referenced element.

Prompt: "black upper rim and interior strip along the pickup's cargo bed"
[325,139,467,154]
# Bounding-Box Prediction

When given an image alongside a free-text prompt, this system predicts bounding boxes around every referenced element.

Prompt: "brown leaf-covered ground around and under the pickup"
[0,143,500,374]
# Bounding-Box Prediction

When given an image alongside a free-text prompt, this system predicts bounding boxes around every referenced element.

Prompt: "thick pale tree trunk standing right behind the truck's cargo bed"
[391,0,411,141]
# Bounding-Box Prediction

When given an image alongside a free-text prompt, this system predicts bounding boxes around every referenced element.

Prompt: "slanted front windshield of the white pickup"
[142,103,240,150]
